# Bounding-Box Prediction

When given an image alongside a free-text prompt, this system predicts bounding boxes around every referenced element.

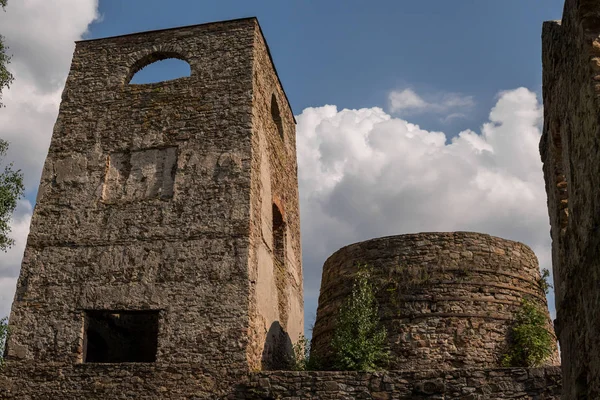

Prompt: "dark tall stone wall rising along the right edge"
[540,0,600,399]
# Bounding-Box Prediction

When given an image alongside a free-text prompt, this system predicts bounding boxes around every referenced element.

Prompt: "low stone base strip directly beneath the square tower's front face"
[0,361,248,400]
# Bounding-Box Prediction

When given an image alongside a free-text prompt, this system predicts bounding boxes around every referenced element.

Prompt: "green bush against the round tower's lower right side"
[502,299,555,367]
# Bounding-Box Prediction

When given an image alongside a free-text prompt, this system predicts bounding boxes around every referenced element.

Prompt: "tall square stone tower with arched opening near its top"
[0,18,304,398]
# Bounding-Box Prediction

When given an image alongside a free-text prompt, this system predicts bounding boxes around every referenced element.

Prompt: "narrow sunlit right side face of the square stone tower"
[245,24,304,369]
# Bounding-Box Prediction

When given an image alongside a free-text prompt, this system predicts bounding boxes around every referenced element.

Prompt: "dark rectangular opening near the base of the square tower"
[83,311,158,363]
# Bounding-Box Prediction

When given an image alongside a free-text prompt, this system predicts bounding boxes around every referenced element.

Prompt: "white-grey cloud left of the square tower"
[0,0,98,317]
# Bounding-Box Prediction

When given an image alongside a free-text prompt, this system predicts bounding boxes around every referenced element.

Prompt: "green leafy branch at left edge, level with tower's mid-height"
[0,139,25,251]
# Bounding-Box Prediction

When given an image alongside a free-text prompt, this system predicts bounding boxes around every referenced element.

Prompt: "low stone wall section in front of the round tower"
[235,367,561,400]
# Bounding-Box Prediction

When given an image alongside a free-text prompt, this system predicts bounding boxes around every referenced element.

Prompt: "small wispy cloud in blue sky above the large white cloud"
[388,89,475,122]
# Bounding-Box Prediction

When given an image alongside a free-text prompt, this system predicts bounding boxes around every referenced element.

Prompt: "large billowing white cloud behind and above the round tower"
[297,88,550,328]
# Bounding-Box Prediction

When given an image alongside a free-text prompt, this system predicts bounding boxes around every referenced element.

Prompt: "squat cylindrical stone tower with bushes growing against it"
[312,232,559,370]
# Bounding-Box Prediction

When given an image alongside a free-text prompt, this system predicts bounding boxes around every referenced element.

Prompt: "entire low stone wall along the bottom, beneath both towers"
[0,362,561,400]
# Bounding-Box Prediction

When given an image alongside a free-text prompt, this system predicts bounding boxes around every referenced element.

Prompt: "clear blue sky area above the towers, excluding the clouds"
[86,0,563,133]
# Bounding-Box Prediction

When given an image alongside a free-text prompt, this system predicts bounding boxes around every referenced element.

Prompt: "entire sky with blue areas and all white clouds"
[0,0,563,340]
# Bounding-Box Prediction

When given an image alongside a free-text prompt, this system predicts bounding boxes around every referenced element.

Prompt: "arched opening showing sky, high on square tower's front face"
[128,52,192,85]
